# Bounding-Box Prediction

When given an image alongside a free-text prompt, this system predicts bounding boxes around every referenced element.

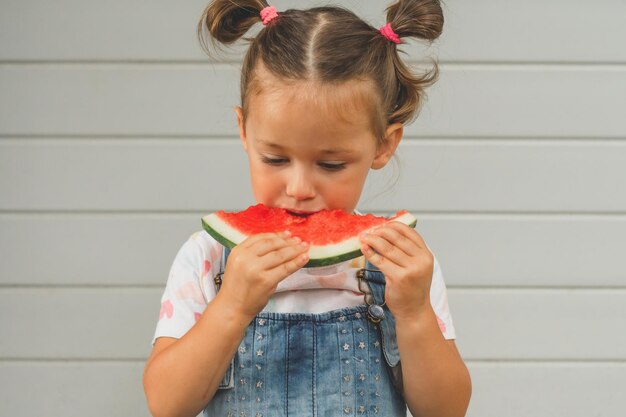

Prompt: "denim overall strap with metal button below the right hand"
[365,261,400,368]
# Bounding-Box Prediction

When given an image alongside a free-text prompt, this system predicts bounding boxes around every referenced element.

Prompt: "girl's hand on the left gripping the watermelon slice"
[218,232,309,319]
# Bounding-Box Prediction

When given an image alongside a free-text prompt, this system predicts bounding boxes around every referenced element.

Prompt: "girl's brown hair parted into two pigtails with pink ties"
[198,0,444,140]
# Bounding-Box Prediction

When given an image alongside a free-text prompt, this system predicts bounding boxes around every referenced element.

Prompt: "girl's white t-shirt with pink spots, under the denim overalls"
[152,231,455,344]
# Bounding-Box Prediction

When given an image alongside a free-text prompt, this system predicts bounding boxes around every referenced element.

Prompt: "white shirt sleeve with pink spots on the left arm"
[152,232,221,345]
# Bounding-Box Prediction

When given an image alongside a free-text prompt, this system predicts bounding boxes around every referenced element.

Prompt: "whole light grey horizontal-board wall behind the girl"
[0,0,626,417]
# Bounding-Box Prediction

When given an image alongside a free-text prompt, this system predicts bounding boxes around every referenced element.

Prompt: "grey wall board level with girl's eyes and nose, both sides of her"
[0,139,626,213]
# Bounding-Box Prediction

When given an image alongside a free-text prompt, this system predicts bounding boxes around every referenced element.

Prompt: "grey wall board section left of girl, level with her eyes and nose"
[0,139,252,211]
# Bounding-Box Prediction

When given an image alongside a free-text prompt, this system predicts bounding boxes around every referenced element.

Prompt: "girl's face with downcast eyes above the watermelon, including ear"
[236,80,402,213]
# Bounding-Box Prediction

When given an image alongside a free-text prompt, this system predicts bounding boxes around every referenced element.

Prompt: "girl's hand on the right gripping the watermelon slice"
[360,222,434,318]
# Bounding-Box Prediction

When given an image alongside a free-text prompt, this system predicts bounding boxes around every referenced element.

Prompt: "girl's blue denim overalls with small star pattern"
[204,248,406,417]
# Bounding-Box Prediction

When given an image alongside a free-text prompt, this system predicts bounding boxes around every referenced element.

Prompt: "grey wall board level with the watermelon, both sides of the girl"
[0,213,626,288]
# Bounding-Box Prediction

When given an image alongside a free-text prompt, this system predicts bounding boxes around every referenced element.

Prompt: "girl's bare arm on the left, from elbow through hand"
[143,234,308,417]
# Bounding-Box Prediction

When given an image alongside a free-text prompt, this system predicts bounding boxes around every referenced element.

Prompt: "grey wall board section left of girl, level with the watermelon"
[0,214,194,286]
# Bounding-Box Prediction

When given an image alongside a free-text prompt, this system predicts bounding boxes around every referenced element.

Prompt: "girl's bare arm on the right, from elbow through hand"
[361,222,471,417]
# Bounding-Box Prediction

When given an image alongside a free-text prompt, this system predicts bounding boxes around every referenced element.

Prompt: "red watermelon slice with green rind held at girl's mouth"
[202,204,417,268]
